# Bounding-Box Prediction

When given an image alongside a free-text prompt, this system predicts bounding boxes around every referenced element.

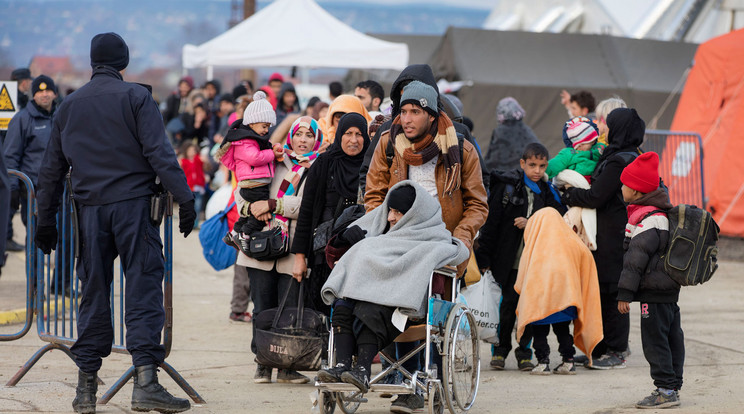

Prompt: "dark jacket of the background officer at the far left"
[3,101,56,190]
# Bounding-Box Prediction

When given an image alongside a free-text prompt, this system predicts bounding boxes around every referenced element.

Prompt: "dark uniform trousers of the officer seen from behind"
[72,197,165,373]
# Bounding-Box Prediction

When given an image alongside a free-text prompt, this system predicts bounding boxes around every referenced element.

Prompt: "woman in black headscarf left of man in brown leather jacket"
[291,112,369,314]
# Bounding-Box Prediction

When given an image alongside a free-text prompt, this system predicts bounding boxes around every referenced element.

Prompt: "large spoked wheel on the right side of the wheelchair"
[442,304,480,413]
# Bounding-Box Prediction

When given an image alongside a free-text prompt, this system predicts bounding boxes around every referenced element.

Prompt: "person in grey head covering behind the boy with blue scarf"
[485,97,540,171]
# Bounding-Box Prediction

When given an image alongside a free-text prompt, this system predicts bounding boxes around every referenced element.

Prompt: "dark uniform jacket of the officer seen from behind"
[37,66,194,225]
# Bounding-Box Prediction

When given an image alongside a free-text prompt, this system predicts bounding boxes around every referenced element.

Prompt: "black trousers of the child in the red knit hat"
[641,303,685,390]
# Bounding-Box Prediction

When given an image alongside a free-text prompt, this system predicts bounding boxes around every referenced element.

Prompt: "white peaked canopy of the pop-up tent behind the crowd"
[183,0,408,76]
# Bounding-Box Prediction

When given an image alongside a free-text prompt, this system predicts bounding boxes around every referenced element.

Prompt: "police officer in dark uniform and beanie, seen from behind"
[35,33,196,413]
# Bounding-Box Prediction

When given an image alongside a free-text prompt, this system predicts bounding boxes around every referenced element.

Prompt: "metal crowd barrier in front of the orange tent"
[643,129,708,209]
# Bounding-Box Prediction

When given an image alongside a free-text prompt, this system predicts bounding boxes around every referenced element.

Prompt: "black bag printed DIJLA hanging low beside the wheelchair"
[253,281,330,371]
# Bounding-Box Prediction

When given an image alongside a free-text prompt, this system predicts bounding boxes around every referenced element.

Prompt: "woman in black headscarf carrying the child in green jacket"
[562,108,646,369]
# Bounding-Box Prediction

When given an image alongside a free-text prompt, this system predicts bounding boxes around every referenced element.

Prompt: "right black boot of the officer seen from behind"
[132,364,191,413]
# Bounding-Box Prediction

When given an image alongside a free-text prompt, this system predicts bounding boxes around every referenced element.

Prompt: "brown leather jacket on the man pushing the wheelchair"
[364,131,488,276]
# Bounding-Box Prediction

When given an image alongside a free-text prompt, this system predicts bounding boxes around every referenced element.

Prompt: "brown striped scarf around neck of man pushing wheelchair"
[390,111,462,196]
